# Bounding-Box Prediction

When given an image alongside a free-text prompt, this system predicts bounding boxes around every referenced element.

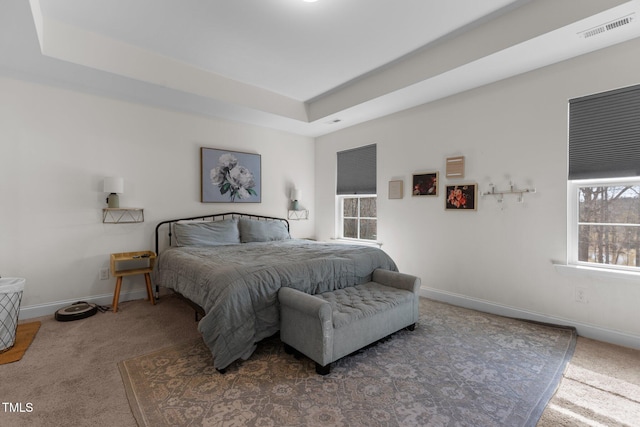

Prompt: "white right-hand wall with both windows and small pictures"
[315,41,640,348]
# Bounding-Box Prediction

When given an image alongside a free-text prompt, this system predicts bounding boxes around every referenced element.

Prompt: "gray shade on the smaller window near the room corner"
[336,144,376,195]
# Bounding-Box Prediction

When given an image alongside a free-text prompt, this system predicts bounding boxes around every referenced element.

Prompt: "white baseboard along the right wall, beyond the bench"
[420,287,640,349]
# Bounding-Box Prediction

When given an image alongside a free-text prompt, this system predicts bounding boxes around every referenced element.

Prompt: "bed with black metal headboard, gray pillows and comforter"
[152,212,397,372]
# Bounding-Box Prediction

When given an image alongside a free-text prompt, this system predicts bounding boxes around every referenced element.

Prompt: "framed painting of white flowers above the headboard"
[200,147,262,203]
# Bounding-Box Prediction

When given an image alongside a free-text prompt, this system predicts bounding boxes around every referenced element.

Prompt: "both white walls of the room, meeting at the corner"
[0,28,640,347]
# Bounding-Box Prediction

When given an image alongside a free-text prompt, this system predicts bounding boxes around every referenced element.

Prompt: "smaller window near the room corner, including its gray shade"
[336,144,378,240]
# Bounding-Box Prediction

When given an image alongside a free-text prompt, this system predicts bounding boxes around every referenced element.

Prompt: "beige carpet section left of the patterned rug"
[0,297,199,427]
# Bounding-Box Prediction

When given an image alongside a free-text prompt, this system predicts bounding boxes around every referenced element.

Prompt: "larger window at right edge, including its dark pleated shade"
[569,85,640,271]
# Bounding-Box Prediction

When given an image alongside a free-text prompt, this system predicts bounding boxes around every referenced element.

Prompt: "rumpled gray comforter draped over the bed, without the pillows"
[153,239,397,369]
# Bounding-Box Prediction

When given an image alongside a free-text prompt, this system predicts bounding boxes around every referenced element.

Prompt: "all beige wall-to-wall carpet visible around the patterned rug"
[0,297,640,427]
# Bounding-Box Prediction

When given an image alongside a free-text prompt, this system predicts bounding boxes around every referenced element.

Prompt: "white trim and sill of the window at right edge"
[554,177,640,281]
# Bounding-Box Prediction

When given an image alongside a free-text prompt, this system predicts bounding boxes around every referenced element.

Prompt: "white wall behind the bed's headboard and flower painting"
[0,78,315,318]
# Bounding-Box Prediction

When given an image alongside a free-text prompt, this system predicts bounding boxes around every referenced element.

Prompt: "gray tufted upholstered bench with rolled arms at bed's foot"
[278,269,420,375]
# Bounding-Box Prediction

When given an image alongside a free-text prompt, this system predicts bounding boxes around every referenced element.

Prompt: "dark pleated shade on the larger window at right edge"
[569,85,640,179]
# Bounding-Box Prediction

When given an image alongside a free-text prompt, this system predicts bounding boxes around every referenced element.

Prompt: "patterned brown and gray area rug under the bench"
[119,298,576,427]
